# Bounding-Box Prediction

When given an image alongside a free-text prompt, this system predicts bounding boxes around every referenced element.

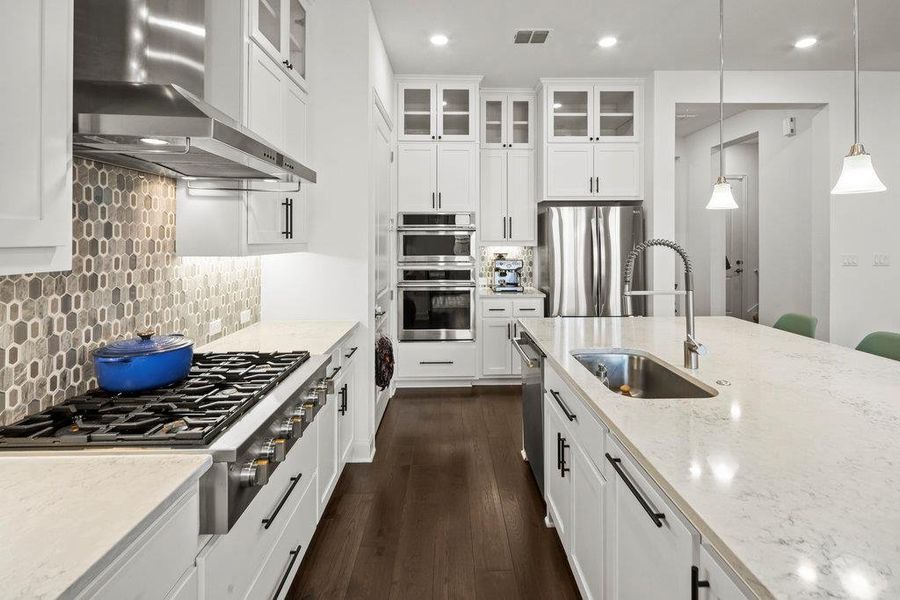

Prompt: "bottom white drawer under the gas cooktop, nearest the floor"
[243,475,317,600]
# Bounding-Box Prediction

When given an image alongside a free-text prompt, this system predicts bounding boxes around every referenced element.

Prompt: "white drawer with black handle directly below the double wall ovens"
[397,342,476,378]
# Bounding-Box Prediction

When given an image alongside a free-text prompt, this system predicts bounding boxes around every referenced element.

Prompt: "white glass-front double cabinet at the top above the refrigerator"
[544,80,641,142]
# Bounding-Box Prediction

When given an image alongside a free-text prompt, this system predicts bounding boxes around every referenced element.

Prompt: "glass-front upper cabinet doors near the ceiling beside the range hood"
[250,0,307,88]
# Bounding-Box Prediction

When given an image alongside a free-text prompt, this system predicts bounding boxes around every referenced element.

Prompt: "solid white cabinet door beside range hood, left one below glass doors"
[247,44,286,148]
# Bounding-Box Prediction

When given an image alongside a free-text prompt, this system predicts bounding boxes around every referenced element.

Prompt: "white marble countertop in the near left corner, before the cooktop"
[0,453,212,600]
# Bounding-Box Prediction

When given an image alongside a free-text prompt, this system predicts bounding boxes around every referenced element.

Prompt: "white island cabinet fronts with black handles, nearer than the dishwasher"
[544,365,755,600]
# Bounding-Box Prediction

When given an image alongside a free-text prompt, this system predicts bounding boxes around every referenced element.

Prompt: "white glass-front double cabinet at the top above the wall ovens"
[397,77,478,142]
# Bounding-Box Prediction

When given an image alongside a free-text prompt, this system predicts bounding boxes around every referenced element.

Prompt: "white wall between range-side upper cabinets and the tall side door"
[262,0,394,460]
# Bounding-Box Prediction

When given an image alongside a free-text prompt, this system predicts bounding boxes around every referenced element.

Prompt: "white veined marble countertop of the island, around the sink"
[520,317,900,600]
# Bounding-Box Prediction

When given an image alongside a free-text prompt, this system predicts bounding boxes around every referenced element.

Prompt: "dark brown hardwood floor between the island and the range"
[288,388,578,600]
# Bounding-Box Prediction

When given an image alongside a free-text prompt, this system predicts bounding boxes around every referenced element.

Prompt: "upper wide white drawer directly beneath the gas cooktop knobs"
[197,426,322,600]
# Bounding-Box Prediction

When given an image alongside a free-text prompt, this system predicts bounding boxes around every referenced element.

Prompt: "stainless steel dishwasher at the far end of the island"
[513,332,544,496]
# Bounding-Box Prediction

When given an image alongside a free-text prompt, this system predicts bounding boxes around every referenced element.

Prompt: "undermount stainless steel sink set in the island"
[572,348,718,399]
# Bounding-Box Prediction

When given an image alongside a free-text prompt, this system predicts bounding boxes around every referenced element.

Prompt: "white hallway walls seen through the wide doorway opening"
[676,109,828,334]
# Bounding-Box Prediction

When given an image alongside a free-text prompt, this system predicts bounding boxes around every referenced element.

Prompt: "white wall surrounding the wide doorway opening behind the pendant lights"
[648,71,900,346]
